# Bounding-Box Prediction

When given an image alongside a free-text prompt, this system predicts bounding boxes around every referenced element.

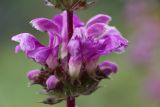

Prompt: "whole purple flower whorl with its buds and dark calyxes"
[12,11,128,104]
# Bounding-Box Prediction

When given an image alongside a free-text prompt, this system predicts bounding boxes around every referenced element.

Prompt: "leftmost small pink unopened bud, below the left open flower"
[27,69,41,81]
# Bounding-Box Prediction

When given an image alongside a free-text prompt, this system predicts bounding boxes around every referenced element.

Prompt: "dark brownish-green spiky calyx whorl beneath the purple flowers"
[40,67,109,105]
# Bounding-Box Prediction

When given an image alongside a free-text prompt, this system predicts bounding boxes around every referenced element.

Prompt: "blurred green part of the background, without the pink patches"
[0,0,160,107]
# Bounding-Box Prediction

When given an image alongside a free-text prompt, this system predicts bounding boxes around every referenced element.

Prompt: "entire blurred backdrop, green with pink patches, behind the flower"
[0,0,160,107]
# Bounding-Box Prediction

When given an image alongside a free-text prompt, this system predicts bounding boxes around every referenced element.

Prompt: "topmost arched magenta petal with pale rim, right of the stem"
[86,14,111,27]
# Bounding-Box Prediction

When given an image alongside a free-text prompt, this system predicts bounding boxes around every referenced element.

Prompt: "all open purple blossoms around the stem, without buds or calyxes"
[12,11,128,76]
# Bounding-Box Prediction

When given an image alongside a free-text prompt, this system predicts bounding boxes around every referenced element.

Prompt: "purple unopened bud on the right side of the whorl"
[99,61,117,77]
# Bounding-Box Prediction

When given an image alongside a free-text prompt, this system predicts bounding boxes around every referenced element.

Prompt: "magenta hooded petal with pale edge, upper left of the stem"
[30,18,59,33]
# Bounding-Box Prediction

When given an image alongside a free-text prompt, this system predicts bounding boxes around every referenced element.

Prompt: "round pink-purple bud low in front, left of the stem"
[46,75,59,90]
